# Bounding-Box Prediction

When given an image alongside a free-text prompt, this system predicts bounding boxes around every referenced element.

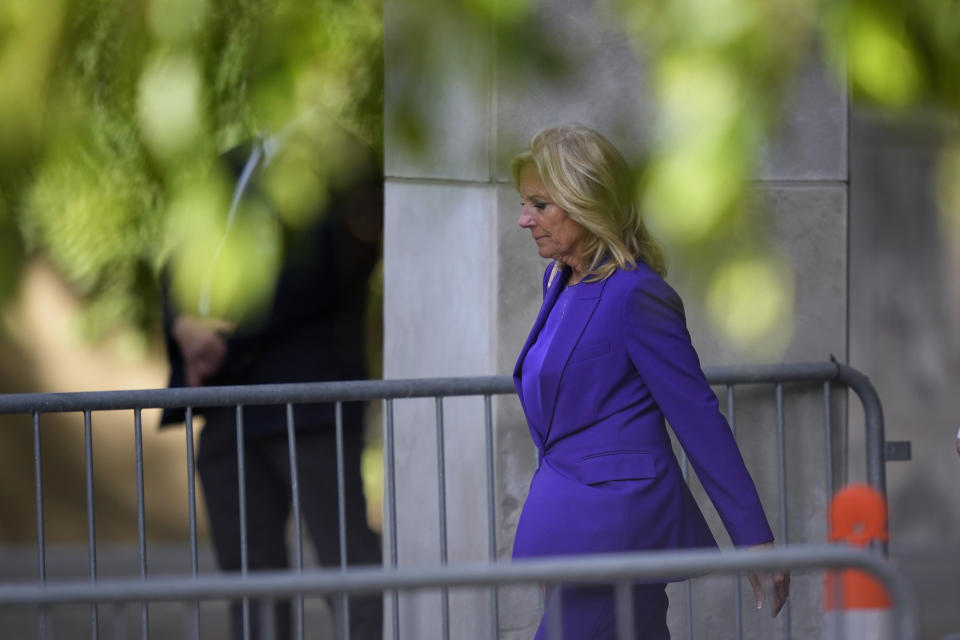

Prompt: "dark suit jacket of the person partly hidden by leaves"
[161,141,383,436]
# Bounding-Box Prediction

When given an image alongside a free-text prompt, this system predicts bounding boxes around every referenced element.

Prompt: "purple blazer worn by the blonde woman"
[513,263,773,558]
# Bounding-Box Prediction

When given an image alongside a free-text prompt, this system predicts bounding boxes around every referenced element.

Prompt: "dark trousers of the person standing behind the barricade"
[197,412,383,640]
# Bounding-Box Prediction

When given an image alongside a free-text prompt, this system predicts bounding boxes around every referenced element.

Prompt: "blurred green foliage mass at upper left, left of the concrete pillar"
[0,0,383,348]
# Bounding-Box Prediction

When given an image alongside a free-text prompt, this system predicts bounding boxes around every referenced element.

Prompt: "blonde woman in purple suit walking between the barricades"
[512,125,789,640]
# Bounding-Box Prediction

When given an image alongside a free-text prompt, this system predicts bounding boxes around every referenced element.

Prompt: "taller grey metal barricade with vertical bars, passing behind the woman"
[0,361,886,638]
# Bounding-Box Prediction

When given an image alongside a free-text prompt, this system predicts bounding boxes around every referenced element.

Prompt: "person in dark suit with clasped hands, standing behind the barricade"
[161,131,383,640]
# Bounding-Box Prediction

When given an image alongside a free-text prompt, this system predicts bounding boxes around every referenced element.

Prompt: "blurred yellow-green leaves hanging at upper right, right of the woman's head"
[608,0,960,359]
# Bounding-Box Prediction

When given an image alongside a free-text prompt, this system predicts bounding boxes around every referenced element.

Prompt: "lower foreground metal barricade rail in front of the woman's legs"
[0,545,916,640]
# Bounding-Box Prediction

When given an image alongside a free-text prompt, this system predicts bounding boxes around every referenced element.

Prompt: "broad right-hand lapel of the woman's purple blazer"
[541,274,606,443]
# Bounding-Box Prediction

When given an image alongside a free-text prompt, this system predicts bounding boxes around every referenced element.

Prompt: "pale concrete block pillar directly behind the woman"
[384,0,847,640]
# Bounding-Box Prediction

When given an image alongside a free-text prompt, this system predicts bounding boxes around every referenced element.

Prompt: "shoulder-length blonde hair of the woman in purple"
[510,124,667,282]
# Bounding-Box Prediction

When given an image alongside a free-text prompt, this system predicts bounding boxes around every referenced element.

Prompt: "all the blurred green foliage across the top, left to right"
[0,0,960,360]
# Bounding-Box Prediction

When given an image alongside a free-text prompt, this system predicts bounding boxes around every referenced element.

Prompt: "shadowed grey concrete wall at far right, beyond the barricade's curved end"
[850,110,960,638]
